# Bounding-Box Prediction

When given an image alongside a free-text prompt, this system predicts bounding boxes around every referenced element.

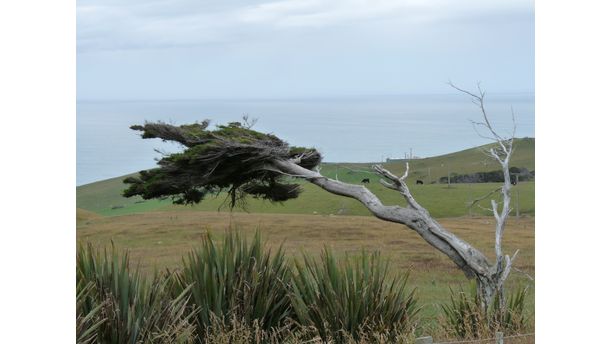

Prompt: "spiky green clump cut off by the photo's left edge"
[77,245,194,344]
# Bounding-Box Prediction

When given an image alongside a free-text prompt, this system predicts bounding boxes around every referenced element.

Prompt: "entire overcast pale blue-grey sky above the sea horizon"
[77,0,534,100]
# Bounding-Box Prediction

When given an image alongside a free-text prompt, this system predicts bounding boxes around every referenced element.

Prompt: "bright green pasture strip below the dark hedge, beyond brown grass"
[77,177,535,217]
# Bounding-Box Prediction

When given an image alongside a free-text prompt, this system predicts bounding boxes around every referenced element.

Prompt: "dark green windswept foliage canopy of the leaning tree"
[123,119,321,208]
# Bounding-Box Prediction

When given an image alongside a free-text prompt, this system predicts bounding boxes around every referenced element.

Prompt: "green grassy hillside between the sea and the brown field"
[76,139,535,217]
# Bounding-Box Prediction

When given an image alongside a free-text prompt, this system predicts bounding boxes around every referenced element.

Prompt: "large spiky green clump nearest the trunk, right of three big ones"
[291,248,418,343]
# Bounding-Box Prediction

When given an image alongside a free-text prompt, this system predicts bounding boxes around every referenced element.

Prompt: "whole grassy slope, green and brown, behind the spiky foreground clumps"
[76,139,535,319]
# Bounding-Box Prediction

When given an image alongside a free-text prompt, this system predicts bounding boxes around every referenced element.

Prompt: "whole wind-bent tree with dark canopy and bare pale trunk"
[124,88,518,307]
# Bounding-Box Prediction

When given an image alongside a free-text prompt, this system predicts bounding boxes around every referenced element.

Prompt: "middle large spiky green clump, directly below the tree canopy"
[175,232,292,336]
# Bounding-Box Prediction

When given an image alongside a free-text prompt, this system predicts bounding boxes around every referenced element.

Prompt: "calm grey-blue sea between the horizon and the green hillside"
[77,94,535,185]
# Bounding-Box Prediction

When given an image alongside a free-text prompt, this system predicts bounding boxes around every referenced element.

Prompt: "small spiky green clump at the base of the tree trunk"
[442,284,529,338]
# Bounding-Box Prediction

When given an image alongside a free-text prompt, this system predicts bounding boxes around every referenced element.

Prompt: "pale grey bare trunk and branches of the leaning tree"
[264,85,518,307]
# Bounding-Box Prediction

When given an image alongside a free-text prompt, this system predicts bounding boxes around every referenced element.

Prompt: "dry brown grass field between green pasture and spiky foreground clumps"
[77,211,535,322]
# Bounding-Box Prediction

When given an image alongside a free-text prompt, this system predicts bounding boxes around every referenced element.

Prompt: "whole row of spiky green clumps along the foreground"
[76,231,527,343]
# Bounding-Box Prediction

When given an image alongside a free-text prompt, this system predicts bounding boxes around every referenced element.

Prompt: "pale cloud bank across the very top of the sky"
[77,0,533,52]
